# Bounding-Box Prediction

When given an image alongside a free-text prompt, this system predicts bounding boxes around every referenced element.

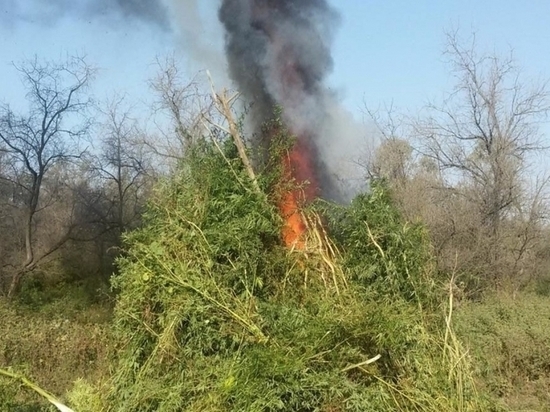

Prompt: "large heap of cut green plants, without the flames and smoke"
[83,135,500,412]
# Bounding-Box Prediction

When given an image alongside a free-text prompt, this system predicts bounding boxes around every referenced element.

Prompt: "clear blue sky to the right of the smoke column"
[333,0,550,115]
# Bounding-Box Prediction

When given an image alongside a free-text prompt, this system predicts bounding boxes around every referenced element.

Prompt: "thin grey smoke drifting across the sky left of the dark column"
[5,0,229,85]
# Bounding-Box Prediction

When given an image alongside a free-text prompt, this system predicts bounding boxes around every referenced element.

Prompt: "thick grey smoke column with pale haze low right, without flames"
[218,0,360,200]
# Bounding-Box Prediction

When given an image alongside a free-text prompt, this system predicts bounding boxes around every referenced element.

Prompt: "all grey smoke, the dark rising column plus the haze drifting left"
[0,0,362,198]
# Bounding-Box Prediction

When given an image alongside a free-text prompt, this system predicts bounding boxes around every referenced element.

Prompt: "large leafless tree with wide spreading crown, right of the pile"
[414,33,550,238]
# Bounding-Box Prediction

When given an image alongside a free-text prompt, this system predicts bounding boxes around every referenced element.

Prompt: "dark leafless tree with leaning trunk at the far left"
[0,57,94,296]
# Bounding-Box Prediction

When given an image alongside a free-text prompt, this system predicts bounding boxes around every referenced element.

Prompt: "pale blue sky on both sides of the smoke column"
[0,0,550,129]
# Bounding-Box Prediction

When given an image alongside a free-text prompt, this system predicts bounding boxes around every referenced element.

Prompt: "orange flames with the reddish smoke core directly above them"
[248,0,319,249]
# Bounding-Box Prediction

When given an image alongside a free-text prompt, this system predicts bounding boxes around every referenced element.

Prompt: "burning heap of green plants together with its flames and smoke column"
[0,0,544,412]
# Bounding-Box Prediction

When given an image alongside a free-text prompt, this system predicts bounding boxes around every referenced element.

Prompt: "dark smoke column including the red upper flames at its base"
[218,0,339,197]
